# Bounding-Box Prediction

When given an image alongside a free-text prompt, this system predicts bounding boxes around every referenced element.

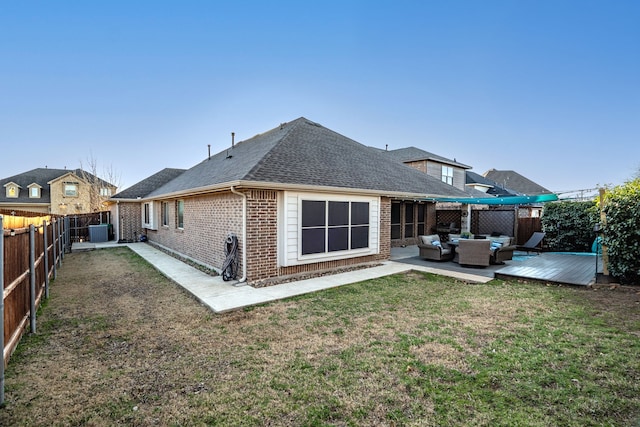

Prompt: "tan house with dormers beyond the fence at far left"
[0,168,116,215]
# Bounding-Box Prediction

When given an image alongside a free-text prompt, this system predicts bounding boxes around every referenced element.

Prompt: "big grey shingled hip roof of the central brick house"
[147,117,465,198]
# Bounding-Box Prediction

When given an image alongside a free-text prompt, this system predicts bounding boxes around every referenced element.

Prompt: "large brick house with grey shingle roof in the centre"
[111,118,465,285]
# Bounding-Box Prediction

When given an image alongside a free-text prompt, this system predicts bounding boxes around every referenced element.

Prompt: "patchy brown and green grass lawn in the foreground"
[0,247,640,426]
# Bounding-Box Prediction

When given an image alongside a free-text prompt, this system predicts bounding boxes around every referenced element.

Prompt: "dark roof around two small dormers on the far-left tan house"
[0,168,92,204]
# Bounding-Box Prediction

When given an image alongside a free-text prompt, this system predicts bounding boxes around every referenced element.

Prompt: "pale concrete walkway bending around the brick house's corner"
[72,242,492,313]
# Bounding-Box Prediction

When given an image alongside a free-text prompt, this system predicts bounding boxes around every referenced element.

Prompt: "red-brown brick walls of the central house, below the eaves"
[121,189,391,286]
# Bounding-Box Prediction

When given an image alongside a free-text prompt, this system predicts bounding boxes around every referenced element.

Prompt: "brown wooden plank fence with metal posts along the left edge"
[0,215,66,404]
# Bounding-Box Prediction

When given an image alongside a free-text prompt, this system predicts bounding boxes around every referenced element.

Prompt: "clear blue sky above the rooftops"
[0,0,640,196]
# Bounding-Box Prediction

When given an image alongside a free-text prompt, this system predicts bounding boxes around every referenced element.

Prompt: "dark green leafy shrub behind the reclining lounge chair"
[541,201,598,252]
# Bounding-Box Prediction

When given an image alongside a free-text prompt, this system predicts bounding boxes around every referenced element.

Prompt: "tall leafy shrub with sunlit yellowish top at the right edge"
[602,178,640,284]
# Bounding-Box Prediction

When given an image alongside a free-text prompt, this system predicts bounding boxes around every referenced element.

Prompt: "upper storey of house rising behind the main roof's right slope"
[380,147,471,191]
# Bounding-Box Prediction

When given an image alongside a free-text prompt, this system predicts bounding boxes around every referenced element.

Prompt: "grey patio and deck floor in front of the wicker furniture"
[391,247,602,286]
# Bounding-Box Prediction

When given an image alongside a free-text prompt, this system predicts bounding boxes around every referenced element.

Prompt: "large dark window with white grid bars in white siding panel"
[302,200,369,255]
